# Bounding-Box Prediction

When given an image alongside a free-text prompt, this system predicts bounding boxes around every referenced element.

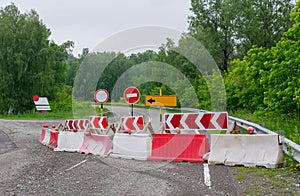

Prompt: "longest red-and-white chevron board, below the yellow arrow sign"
[164,112,228,130]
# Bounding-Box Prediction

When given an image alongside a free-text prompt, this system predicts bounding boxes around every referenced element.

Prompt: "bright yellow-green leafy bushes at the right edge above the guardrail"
[225,2,300,113]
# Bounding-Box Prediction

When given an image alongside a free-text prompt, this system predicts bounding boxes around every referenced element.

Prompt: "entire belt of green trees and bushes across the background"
[0,0,300,118]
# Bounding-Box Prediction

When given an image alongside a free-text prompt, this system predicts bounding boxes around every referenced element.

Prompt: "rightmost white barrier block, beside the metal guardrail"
[208,134,284,168]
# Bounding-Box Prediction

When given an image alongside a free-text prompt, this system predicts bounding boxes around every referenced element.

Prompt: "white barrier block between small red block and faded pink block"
[54,131,84,152]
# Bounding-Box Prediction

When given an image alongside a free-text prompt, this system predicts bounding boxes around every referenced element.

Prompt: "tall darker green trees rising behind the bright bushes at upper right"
[189,0,293,71]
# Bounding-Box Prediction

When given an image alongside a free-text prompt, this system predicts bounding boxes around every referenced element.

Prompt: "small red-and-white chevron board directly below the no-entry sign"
[121,116,144,131]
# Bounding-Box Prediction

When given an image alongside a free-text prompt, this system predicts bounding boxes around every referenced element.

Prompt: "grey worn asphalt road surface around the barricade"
[0,107,241,195]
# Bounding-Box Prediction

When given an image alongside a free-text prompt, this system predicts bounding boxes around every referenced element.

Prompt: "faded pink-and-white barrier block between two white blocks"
[79,134,112,156]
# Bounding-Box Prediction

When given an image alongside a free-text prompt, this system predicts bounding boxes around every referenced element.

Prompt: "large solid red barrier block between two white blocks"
[148,134,210,162]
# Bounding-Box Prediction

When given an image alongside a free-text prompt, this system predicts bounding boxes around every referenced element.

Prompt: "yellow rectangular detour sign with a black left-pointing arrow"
[146,95,177,106]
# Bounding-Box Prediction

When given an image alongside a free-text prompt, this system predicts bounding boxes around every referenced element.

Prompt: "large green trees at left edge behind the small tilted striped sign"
[0,4,72,114]
